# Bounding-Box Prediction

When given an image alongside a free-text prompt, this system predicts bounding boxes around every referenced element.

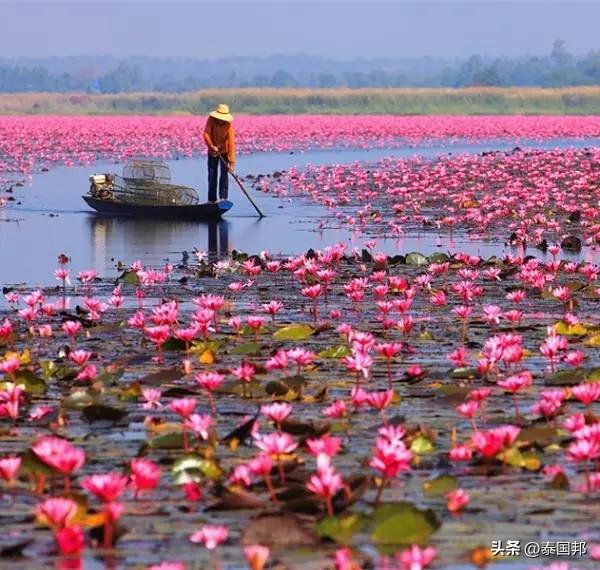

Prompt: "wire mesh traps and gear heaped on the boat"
[90,159,199,206]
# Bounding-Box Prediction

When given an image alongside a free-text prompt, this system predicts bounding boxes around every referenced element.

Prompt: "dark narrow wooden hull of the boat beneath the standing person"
[82,196,233,220]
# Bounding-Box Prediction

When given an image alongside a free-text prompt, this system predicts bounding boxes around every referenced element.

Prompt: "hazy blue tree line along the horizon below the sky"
[0,40,600,93]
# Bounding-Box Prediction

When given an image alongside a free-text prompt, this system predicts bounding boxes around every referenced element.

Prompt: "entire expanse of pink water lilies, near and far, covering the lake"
[0,116,600,570]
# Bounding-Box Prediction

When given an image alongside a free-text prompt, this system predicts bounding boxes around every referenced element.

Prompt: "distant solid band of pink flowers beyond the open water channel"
[0,115,600,180]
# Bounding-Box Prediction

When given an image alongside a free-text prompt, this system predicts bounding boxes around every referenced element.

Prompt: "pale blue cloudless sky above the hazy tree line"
[0,0,600,59]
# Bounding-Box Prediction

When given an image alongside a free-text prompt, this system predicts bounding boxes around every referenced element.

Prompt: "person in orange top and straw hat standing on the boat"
[204,103,235,202]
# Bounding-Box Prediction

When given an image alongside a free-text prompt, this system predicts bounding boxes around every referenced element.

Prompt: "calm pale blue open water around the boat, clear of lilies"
[0,140,597,285]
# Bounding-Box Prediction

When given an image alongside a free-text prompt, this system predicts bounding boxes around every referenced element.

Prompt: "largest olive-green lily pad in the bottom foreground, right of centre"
[371,501,441,545]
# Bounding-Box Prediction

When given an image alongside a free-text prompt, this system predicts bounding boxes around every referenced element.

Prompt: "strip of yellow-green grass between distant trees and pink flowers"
[0,86,600,115]
